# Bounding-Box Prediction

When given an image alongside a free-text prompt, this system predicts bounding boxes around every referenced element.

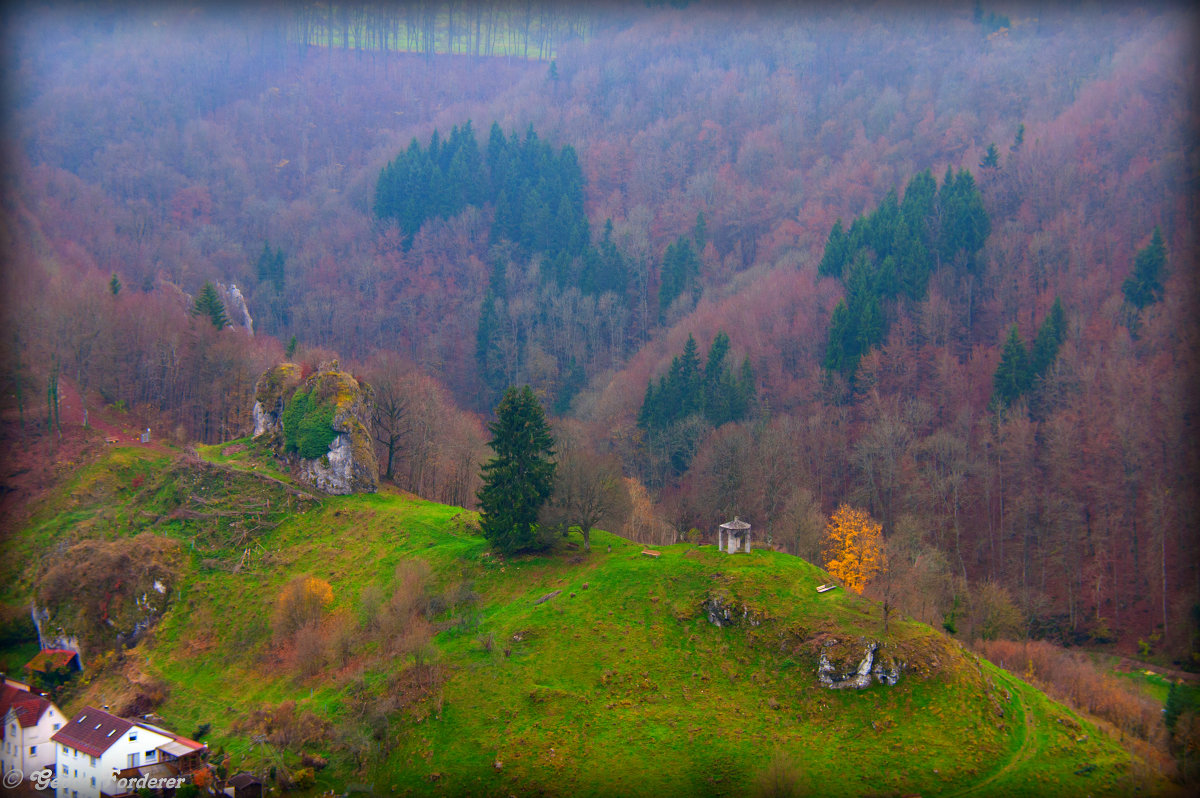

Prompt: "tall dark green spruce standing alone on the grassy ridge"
[478,385,556,552]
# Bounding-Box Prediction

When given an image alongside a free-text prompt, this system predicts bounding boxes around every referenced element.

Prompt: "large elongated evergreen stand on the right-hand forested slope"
[817,169,991,377]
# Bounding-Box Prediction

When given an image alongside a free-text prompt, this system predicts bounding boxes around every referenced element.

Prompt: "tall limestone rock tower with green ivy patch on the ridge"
[254,360,379,494]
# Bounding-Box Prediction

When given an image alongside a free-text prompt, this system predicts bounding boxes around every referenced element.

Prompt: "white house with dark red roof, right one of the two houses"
[52,707,208,798]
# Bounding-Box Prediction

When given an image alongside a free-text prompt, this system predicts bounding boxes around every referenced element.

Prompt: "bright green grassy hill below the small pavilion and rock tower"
[4,442,1169,796]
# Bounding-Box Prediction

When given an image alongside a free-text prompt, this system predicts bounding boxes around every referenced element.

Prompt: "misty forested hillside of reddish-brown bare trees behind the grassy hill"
[2,4,1200,665]
